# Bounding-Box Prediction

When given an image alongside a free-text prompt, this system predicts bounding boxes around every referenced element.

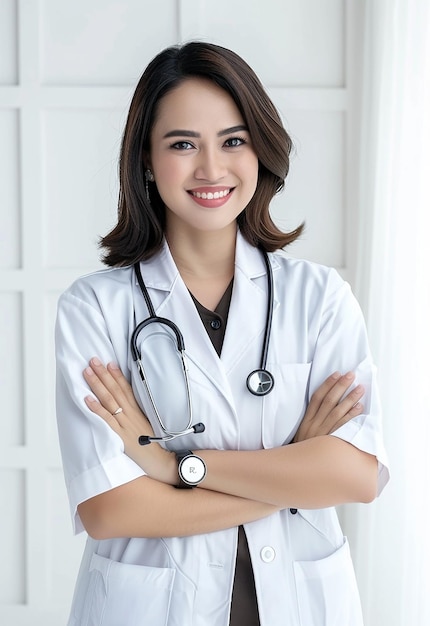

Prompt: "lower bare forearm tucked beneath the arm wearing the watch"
[78,477,278,539]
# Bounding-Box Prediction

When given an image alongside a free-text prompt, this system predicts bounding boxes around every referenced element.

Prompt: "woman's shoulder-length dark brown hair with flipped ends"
[100,42,303,266]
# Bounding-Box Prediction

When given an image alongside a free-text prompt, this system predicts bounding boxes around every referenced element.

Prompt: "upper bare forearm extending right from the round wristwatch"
[198,436,377,508]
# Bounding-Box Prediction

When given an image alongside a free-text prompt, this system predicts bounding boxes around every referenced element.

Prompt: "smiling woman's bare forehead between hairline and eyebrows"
[153,78,244,134]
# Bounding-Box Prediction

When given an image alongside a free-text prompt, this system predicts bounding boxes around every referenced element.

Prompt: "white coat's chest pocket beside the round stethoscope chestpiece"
[262,363,312,448]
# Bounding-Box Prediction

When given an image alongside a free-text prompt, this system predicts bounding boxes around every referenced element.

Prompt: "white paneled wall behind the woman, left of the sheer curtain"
[0,0,360,626]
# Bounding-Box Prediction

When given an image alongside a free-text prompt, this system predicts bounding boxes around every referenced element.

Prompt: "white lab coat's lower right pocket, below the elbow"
[294,537,363,626]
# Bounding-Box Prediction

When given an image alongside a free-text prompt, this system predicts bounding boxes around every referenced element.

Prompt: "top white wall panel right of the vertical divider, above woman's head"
[182,0,345,87]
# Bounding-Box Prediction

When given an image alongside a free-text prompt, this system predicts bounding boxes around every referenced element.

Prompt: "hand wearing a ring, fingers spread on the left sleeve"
[83,357,176,484]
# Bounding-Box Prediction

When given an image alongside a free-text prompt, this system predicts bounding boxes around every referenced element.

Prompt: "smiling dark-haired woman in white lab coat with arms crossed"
[57,43,388,626]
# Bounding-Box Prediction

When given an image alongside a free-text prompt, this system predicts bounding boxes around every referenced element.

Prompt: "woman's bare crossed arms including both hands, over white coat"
[78,359,377,539]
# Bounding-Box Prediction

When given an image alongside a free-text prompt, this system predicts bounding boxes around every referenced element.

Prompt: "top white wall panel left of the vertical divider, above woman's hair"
[41,0,177,86]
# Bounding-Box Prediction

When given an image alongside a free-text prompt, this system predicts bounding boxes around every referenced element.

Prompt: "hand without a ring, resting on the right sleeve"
[293,372,364,443]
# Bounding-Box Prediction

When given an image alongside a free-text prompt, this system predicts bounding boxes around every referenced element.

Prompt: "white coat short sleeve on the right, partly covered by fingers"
[309,270,389,495]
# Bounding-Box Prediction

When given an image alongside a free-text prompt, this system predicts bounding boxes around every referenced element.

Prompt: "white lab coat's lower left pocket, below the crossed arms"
[82,554,192,626]
